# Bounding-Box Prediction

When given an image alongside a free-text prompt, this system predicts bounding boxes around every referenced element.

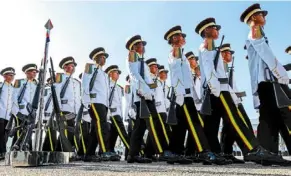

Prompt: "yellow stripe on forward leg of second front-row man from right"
[220,94,253,150]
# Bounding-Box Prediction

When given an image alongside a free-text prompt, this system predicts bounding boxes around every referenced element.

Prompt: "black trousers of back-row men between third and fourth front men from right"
[144,113,170,157]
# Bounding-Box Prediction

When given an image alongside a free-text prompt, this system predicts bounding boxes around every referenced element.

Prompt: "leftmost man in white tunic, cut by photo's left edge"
[0,67,15,160]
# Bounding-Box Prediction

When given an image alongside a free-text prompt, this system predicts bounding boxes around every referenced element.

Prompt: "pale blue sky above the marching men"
[0,1,291,118]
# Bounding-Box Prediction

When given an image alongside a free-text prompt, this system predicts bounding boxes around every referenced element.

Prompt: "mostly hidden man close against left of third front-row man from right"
[158,65,170,113]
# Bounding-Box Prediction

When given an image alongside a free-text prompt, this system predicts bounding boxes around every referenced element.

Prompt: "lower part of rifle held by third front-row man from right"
[166,86,178,125]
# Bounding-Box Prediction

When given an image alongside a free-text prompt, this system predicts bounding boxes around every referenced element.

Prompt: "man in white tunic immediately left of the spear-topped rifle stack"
[12,64,38,149]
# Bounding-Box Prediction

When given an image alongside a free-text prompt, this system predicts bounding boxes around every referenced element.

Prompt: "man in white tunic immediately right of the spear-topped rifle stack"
[55,56,81,151]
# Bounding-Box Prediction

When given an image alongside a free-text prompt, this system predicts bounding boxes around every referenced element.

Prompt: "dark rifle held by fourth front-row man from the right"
[139,48,150,119]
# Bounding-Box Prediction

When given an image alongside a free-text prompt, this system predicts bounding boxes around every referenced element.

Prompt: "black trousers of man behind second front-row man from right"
[220,103,254,154]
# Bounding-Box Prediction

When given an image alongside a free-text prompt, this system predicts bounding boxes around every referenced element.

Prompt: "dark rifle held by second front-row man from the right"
[200,35,224,115]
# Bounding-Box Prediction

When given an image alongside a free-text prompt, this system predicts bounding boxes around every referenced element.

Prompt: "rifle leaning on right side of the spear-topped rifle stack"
[49,58,72,152]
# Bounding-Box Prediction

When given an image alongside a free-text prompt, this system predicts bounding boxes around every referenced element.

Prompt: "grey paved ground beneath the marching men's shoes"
[0,158,291,176]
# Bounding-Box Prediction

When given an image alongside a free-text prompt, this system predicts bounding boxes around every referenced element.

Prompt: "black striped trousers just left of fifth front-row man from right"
[78,121,91,156]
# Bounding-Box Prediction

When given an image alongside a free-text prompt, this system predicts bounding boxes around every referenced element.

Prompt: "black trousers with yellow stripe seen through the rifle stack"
[42,121,57,152]
